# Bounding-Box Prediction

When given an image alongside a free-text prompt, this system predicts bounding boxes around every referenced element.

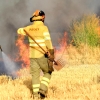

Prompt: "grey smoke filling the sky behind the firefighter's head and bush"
[0,0,100,58]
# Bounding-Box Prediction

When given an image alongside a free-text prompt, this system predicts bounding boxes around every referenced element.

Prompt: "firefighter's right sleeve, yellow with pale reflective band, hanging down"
[43,27,53,49]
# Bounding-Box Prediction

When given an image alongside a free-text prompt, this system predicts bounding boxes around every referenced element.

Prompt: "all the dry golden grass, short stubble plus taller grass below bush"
[0,46,100,100]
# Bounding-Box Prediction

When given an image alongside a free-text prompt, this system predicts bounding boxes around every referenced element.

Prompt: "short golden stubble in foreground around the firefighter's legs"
[0,64,100,100]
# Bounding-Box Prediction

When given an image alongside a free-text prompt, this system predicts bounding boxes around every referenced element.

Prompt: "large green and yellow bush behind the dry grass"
[70,14,100,47]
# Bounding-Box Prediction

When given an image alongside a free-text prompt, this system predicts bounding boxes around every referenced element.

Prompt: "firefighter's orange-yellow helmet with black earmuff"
[30,10,45,22]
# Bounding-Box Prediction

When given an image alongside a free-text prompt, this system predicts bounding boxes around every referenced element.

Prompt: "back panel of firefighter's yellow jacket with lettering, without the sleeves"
[25,21,47,58]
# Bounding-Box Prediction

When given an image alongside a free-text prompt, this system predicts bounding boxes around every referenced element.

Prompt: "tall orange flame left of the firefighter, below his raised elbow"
[16,36,30,68]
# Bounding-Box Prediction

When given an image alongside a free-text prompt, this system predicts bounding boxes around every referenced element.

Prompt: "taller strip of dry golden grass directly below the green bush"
[64,45,100,65]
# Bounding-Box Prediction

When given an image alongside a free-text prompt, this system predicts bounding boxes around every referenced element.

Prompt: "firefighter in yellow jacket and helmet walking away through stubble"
[17,10,54,99]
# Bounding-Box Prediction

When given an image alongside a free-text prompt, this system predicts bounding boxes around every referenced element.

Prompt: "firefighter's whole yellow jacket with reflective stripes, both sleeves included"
[17,21,53,58]
